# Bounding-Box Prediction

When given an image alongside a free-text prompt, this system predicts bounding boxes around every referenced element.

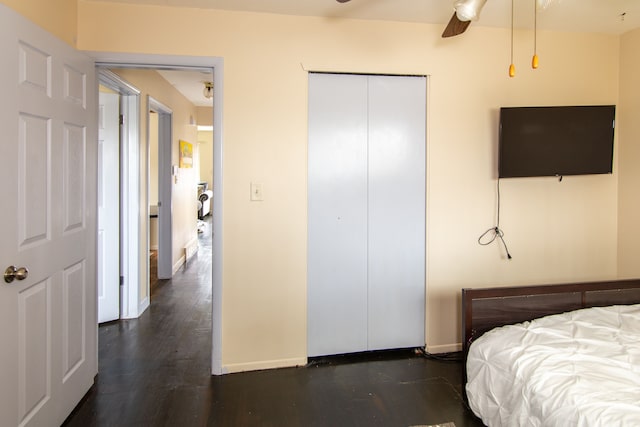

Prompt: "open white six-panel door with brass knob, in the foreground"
[0,5,97,426]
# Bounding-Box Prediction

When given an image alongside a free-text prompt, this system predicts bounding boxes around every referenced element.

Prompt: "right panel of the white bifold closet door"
[368,76,426,350]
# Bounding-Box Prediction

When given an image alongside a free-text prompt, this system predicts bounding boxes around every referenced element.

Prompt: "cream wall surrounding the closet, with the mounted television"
[79,0,620,371]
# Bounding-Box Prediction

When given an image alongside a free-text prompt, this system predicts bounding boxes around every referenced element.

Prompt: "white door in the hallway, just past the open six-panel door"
[97,92,120,323]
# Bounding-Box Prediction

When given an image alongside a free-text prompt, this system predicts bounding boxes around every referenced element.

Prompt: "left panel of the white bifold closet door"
[307,74,367,357]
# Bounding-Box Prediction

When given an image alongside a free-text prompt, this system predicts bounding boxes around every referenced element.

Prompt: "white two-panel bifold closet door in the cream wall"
[307,73,426,356]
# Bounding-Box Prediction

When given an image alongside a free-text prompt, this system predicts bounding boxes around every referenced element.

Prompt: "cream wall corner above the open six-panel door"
[0,0,78,46]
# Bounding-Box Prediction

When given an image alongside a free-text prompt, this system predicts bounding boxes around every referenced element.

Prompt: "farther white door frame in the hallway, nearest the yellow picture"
[146,95,173,280]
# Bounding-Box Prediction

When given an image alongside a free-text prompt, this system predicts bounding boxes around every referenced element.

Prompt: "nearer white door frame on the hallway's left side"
[98,66,142,319]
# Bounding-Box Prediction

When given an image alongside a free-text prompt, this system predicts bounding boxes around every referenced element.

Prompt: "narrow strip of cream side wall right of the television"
[617,30,640,278]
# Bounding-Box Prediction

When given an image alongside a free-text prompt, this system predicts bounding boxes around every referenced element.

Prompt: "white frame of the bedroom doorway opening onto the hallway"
[87,52,224,375]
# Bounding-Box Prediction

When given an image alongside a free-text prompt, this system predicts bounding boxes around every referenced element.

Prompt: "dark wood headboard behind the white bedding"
[462,279,640,359]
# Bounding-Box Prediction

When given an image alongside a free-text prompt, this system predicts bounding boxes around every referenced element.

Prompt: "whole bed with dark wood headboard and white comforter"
[462,280,640,427]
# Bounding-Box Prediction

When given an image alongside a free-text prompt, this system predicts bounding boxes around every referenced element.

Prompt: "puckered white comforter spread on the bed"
[466,304,640,427]
